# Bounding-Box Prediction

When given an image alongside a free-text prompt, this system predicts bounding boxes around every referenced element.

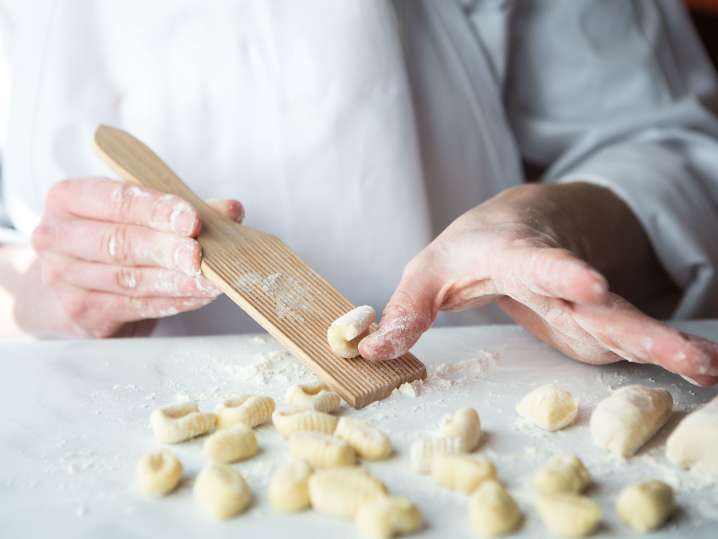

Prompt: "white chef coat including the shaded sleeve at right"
[0,0,718,334]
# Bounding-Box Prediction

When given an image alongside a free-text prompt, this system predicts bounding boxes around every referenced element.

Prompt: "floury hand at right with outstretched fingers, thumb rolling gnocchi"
[359,183,718,385]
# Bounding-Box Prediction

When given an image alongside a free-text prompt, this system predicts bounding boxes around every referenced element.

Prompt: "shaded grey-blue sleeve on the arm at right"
[506,0,718,318]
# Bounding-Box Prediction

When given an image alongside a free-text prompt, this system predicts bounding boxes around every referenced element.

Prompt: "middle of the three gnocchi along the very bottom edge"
[469,480,522,537]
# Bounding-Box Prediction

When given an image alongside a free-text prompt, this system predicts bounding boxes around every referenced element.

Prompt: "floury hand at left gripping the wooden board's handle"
[32,178,244,338]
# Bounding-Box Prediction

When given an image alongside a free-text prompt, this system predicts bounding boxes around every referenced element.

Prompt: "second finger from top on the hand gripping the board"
[32,220,202,276]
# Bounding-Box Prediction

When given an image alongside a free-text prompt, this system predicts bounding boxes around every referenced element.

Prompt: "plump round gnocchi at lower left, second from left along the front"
[194,464,252,520]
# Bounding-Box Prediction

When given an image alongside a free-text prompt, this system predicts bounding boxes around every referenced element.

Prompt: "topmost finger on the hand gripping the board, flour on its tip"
[47,178,201,236]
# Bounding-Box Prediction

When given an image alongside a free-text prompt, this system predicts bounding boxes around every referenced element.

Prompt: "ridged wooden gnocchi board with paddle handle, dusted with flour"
[95,126,426,408]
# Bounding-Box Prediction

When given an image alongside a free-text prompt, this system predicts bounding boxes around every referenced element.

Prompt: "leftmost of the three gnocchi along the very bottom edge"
[356,496,424,539]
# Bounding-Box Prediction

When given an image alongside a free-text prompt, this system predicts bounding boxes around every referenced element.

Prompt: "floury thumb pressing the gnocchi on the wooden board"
[359,259,441,361]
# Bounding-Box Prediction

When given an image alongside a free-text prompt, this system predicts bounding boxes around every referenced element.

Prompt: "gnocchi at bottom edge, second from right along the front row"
[536,494,601,537]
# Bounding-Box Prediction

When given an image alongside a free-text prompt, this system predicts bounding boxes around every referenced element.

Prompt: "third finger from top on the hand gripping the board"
[42,253,221,298]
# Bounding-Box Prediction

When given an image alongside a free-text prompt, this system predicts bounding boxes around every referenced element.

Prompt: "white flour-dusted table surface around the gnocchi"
[0,322,718,539]
